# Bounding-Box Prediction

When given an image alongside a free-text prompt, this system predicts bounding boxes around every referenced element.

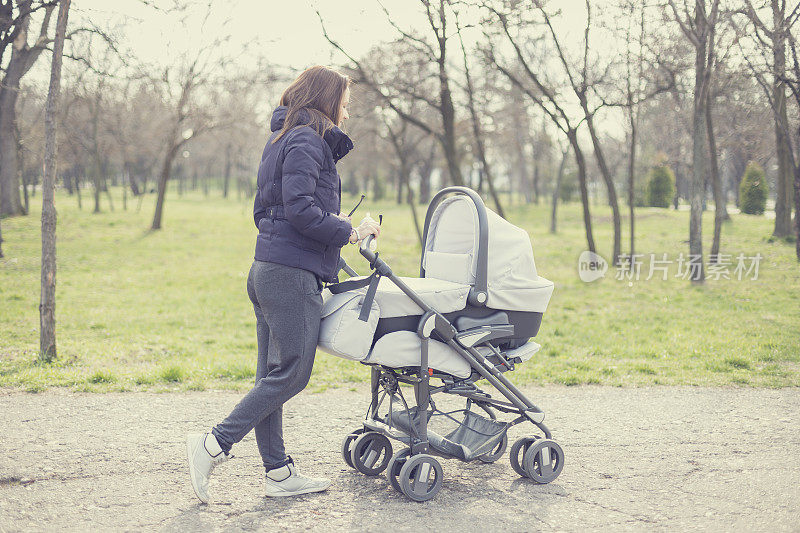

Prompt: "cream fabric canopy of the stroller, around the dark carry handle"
[422,195,553,313]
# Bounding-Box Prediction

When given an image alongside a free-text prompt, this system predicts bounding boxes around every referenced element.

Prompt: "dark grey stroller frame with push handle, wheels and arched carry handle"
[339,187,563,501]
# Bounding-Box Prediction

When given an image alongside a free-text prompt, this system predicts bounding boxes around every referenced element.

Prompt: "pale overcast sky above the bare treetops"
[73,0,606,70]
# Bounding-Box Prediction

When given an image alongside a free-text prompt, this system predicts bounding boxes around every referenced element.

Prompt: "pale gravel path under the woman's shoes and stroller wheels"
[0,387,800,531]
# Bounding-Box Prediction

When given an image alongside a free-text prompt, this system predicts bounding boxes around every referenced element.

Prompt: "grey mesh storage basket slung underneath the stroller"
[384,406,512,461]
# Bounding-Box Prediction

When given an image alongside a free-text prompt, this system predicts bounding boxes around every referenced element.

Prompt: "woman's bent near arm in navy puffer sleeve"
[282,128,352,246]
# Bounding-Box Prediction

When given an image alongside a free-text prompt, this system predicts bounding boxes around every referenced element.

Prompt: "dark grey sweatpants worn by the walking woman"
[216,261,322,470]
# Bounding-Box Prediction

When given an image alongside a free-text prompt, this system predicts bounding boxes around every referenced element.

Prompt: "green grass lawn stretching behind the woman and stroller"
[0,187,800,391]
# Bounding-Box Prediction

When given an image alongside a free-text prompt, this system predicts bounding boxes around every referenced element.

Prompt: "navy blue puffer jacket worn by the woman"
[253,106,353,281]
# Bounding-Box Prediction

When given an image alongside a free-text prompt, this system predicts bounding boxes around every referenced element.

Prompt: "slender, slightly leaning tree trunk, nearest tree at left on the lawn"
[39,0,70,363]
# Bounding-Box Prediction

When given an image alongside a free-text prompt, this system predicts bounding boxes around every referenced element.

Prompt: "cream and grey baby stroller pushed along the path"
[319,187,564,501]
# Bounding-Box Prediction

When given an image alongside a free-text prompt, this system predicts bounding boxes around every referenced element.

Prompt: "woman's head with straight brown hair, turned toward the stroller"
[272,65,350,143]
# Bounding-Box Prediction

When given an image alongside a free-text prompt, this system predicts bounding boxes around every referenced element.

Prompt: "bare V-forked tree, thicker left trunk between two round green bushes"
[668,0,719,283]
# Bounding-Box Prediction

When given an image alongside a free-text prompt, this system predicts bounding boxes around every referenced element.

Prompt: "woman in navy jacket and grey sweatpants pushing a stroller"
[187,66,380,503]
